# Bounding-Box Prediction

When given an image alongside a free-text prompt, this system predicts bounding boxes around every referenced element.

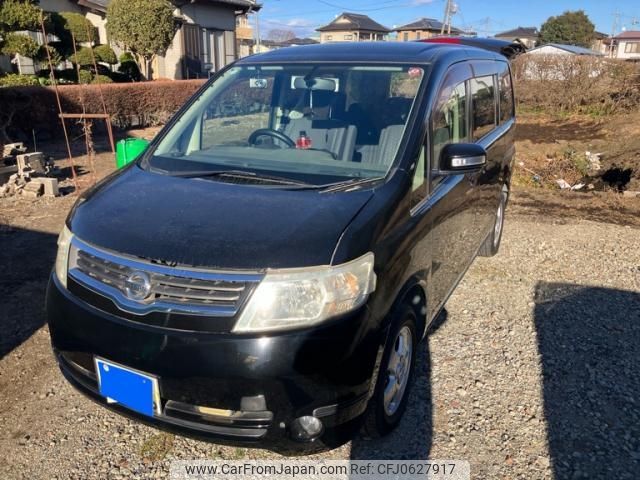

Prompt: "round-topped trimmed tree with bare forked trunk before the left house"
[107,0,175,78]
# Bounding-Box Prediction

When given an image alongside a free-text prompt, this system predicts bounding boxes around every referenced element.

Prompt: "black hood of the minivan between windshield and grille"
[68,166,373,270]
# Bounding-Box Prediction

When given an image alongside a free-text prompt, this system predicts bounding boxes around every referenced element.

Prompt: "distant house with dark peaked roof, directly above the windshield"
[316,12,390,43]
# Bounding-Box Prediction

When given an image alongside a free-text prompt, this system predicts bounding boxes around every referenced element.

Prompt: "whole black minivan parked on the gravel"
[47,42,515,449]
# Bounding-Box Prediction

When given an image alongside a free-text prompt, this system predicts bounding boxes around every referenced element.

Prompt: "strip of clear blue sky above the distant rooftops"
[252,0,640,38]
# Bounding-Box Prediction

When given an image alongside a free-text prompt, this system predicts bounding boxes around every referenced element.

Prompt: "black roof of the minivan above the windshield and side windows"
[238,42,504,64]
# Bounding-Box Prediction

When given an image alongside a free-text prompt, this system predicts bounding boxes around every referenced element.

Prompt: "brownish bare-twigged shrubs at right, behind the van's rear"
[513,55,640,115]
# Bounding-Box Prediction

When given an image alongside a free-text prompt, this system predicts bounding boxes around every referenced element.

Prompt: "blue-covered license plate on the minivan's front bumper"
[95,358,160,417]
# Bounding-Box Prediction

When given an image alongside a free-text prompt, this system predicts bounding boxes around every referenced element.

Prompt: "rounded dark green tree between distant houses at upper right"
[540,10,595,48]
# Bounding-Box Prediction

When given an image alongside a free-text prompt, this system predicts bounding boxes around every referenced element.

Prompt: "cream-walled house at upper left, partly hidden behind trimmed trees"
[6,0,261,79]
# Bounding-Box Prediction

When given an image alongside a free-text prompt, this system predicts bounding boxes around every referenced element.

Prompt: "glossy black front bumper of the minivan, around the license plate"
[47,274,384,450]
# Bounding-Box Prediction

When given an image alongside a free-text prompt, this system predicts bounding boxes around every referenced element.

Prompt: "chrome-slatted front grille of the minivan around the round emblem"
[69,239,261,316]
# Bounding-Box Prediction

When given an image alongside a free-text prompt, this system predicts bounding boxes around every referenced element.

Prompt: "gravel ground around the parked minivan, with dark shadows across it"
[0,189,640,480]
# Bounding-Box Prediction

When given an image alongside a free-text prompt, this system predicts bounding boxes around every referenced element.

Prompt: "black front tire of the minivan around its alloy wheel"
[362,306,418,438]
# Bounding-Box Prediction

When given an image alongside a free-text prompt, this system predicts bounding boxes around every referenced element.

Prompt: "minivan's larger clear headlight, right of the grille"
[233,253,376,332]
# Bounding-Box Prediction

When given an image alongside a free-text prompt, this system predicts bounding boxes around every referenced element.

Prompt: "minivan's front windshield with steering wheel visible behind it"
[148,64,424,185]
